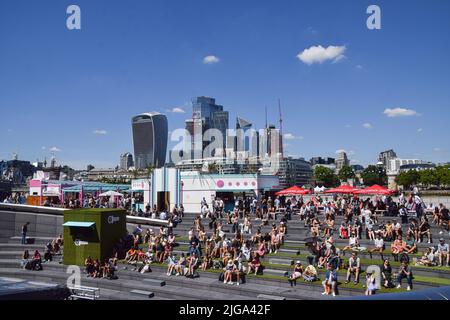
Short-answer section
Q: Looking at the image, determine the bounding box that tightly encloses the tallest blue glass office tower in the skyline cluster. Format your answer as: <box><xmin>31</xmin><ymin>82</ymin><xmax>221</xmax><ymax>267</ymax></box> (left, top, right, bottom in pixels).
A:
<box><xmin>186</xmin><ymin>97</ymin><xmax>229</xmax><ymax>158</ymax></box>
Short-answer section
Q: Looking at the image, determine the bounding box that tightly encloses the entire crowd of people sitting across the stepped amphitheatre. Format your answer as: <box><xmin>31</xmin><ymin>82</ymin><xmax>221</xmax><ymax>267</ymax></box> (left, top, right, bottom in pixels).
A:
<box><xmin>14</xmin><ymin>190</ymin><xmax>450</xmax><ymax>296</ymax></box>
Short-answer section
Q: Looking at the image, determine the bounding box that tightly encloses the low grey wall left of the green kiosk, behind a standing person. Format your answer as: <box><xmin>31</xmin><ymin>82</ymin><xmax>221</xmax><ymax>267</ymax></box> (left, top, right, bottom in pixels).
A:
<box><xmin>0</xmin><ymin>211</ymin><xmax>63</xmax><ymax>239</ymax></box>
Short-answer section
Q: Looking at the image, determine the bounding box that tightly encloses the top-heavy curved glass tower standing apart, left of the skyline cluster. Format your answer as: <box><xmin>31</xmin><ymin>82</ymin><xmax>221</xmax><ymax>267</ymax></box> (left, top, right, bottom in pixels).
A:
<box><xmin>131</xmin><ymin>112</ymin><xmax>168</xmax><ymax>169</ymax></box>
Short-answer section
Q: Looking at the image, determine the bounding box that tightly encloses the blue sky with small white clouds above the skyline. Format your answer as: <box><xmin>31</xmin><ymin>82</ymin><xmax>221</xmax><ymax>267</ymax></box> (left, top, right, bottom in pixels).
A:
<box><xmin>0</xmin><ymin>0</ymin><xmax>450</xmax><ymax>168</ymax></box>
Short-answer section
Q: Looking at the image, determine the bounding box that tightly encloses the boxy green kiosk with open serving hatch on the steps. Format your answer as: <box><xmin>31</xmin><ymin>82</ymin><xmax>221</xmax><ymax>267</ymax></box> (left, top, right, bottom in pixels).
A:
<box><xmin>63</xmin><ymin>209</ymin><xmax>127</xmax><ymax>266</ymax></box>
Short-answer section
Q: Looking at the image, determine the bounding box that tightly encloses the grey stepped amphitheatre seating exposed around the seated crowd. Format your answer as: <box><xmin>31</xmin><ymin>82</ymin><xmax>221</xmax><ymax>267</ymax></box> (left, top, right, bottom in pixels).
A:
<box><xmin>0</xmin><ymin>206</ymin><xmax>450</xmax><ymax>300</ymax></box>
